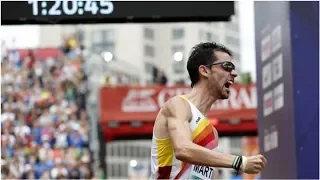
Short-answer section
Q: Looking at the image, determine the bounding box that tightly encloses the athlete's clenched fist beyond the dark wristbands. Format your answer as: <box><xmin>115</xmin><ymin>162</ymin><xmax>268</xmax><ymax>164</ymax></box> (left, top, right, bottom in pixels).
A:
<box><xmin>242</xmin><ymin>154</ymin><xmax>267</xmax><ymax>174</ymax></box>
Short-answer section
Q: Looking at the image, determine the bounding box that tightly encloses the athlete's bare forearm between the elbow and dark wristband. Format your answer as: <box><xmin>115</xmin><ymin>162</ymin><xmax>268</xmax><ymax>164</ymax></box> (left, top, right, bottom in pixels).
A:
<box><xmin>176</xmin><ymin>143</ymin><xmax>236</xmax><ymax>168</ymax></box>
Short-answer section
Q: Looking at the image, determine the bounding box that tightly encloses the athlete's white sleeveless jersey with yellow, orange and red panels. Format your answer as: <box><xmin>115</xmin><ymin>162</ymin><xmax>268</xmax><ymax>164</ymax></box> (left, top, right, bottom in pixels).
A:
<box><xmin>151</xmin><ymin>96</ymin><xmax>218</xmax><ymax>179</ymax></box>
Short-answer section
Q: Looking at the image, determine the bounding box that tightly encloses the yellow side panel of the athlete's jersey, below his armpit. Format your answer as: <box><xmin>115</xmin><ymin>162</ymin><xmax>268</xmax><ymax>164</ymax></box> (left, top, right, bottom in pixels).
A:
<box><xmin>156</xmin><ymin>138</ymin><xmax>174</xmax><ymax>167</ymax></box>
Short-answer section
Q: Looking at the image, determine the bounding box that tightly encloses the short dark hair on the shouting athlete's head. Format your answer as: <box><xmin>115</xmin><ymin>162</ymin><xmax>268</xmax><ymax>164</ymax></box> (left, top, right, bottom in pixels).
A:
<box><xmin>187</xmin><ymin>42</ymin><xmax>232</xmax><ymax>87</ymax></box>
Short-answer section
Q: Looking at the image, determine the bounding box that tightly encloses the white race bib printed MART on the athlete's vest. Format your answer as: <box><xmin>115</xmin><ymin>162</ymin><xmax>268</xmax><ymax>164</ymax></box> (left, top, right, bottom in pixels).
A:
<box><xmin>189</xmin><ymin>165</ymin><xmax>214</xmax><ymax>179</ymax></box>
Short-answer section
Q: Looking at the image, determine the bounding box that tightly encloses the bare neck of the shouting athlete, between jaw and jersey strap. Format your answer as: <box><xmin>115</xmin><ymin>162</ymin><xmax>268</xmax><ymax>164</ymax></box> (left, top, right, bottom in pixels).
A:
<box><xmin>186</xmin><ymin>84</ymin><xmax>218</xmax><ymax>116</ymax></box>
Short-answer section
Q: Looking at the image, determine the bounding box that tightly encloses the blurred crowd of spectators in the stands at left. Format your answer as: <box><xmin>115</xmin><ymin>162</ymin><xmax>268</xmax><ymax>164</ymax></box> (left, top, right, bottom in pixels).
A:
<box><xmin>1</xmin><ymin>36</ymin><xmax>93</xmax><ymax>179</ymax></box>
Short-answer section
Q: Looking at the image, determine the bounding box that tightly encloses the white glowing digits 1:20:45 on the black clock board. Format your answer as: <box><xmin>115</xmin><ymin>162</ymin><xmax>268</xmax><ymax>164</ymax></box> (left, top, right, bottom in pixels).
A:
<box><xmin>28</xmin><ymin>0</ymin><xmax>114</xmax><ymax>16</ymax></box>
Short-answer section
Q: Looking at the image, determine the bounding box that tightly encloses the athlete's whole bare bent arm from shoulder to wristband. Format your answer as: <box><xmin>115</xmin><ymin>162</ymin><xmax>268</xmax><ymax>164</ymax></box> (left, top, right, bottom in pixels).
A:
<box><xmin>163</xmin><ymin>97</ymin><xmax>235</xmax><ymax>168</ymax></box>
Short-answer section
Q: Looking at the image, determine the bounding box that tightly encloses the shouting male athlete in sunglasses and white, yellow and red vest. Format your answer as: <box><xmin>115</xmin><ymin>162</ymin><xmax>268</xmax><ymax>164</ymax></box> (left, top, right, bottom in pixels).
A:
<box><xmin>151</xmin><ymin>43</ymin><xmax>267</xmax><ymax>179</ymax></box>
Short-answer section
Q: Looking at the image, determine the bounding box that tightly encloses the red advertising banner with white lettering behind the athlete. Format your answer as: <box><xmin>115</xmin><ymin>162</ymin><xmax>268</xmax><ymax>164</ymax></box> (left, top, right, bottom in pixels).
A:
<box><xmin>100</xmin><ymin>85</ymin><xmax>257</xmax><ymax>123</ymax></box>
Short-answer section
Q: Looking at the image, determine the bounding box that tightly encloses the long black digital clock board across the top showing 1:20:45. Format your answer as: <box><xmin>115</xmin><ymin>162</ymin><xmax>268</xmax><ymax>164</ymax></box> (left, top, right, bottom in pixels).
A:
<box><xmin>1</xmin><ymin>0</ymin><xmax>234</xmax><ymax>25</ymax></box>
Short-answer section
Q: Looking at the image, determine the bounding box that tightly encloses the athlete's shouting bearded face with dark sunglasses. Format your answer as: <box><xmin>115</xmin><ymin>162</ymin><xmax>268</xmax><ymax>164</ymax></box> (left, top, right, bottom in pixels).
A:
<box><xmin>200</xmin><ymin>51</ymin><xmax>238</xmax><ymax>99</ymax></box>
